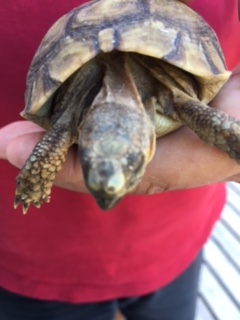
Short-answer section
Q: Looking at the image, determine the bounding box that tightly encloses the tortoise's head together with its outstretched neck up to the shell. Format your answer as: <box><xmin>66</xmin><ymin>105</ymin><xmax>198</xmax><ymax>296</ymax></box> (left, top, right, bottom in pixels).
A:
<box><xmin>78</xmin><ymin>55</ymin><xmax>155</xmax><ymax>210</ymax></box>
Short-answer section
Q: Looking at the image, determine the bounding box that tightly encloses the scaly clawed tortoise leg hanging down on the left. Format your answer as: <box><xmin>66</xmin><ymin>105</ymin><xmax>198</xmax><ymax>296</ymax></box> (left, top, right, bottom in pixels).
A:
<box><xmin>14</xmin><ymin>124</ymin><xmax>73</xmax><ymax>214</ymax></box>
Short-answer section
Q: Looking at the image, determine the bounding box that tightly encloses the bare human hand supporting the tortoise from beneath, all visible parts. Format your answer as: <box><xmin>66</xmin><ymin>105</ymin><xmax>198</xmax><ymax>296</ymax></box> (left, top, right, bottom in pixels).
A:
<box><xmin>0</xmin><ymin>66</ymin><xmax>240</xmax><ymax>194</ymax></box>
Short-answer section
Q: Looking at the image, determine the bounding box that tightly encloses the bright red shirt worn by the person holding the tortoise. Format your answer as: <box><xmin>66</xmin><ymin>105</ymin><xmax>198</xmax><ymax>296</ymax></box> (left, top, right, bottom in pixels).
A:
<box><xmin>0</xmin><ymin>0</ymin><xmax>240</xmax><ymax>302</ymax></box>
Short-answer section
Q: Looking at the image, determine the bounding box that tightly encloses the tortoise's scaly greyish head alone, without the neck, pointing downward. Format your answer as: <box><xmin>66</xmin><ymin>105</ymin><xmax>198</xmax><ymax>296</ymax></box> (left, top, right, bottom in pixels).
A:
<box><xmin>79</xmin><ymin>102</ymin><xmax>155</xmax><ymax>210</ymax></box>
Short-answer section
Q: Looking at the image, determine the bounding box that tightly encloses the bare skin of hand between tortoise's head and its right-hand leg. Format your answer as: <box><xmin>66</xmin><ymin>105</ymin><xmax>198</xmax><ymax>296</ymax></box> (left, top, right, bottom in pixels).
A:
<box><xmin>136</xmin><ymin>128</ymin><xmax>240</xmax><ymax>194</ymax></box>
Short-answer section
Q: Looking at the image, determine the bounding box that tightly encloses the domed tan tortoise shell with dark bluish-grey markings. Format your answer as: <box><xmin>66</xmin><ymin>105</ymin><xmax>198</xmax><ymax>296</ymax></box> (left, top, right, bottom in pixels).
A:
<box><xmin>22</xmin><ymin>0</ymin><xmax>230</xmax><ymax>126</ymax></box>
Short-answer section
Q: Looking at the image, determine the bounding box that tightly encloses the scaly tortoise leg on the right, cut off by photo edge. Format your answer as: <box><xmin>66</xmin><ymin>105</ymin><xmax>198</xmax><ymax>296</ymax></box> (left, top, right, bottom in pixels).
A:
<box><xmin>175</xmin><ymin>98</ymin><xmax>240</xmax><ymax>163</ymax></box>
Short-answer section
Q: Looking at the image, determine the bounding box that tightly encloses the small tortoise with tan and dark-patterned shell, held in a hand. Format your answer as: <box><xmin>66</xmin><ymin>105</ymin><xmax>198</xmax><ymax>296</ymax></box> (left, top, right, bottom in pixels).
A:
<box><xmin>14</xmin><ymin>0</ymin><xmax>240</xmax><ymax>213</ymax></box>
